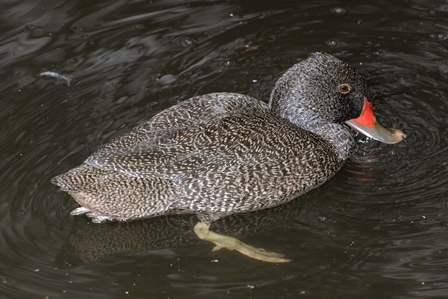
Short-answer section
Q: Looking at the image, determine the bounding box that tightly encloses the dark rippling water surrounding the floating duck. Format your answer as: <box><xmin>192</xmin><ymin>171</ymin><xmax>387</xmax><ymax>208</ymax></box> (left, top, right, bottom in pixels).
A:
<box><xmin>0</xmin><ymin>0</ymin><xmax>448</xmax><ymax>299</ymax></box>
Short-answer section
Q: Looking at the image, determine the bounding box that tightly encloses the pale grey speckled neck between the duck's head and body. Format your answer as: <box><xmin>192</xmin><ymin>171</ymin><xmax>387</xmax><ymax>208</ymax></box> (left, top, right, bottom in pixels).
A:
<box><xmin>269</xmin><ymin>98</ymin><xmax>355</xmax><ymax>161</ymax></box>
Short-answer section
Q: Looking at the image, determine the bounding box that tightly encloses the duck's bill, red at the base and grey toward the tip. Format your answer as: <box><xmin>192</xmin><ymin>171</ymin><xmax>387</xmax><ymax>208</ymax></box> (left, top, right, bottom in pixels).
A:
<box><xmin>345</xmin><ymin>99</ymin><xmax>406</xmax><ymax>144</ymax></box>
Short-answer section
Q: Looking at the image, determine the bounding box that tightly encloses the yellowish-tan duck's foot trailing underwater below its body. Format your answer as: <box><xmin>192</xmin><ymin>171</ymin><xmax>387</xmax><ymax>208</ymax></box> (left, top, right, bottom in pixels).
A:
<box><xmin>194</xmin><ymin>222</ymin><xmax>291</xmax><ymax>263</ymax></box>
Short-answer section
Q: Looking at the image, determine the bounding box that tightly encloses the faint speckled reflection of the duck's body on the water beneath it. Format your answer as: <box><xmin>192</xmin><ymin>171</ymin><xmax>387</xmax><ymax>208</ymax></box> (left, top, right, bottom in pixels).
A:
<box><xmin>56</xmin><ymin>190</ymin><xmax>328</xmax><ymax>266</ymax></box>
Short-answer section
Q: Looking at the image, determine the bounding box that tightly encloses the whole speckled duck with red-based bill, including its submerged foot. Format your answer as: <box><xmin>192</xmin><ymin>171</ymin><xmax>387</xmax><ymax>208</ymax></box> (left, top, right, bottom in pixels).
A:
<box><xmin>52</xmin><ymin>53</ymin><xmax>405</xmax><ymax>262</ymax></box>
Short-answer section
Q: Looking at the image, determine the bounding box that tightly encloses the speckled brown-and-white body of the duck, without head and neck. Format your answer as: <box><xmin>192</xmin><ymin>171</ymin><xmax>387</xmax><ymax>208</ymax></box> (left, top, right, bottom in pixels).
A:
<box><xmin>53</xmin><ymin>93</ymin><xmax>343</xmax><ymax>220</ymax></box>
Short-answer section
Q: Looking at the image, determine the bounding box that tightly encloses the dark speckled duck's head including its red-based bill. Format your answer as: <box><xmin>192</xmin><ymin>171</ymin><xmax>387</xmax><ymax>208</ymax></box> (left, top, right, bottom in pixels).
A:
<box><xmin>269</xmin><ymin>53</ymin><xmax>405</xmax><ymax>143</ymax></box>
